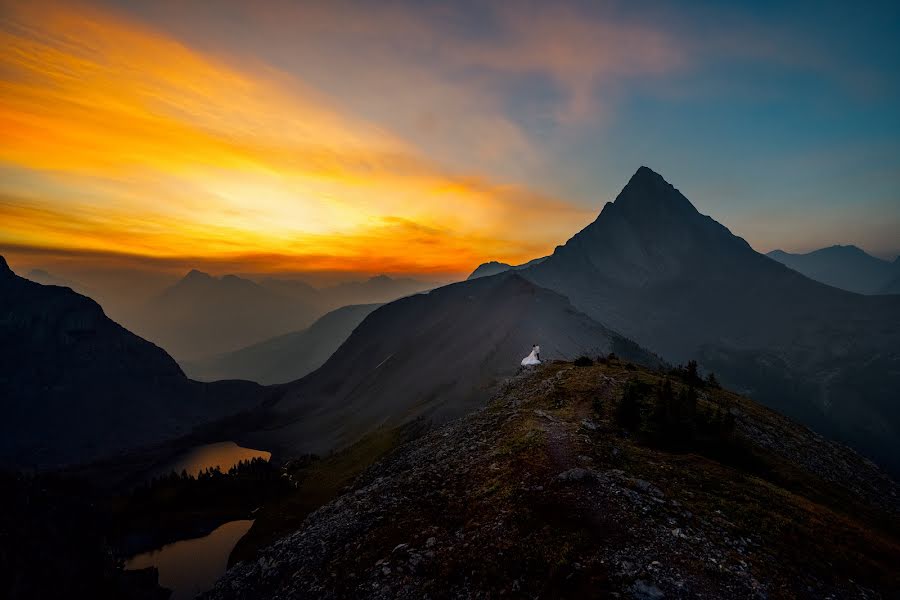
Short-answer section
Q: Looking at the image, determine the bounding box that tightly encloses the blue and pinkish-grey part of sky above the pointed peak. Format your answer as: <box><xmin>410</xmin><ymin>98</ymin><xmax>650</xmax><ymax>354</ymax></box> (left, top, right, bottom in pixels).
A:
<box><xmin>121</xmin><ymin>2</ymin><xmax>900</xmax><ymax>256</ymax></box>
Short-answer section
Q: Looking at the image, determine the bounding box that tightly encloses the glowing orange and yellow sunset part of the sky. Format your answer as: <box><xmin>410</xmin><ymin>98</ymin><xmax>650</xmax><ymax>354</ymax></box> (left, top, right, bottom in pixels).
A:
<box><xmin>0</xmin><ymin>3</ymin><xmax>594</xmax><ymax>274</ymax></box>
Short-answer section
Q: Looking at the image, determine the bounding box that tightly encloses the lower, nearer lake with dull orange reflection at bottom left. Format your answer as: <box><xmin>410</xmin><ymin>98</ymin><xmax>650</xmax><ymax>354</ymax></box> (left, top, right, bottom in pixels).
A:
<box><xmin>125</xmin><ymin>520</ymin><xmax>253</xmax><ymax>600</ymax></box>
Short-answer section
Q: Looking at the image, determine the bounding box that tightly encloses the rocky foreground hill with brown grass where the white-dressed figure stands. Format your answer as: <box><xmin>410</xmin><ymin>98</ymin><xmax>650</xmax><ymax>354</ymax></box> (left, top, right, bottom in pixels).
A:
<box><xmin>206</xmin><ymin>361</ymin><xmax>900</xmax><ymax>600</ymax></box>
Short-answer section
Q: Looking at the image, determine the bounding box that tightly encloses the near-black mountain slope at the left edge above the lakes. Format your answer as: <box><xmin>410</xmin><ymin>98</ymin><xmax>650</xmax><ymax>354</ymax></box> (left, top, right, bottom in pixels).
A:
<box><xmin>0</xmin><ymin>257</ymin><xmax>260</xmax><ymax>467</ymax></box>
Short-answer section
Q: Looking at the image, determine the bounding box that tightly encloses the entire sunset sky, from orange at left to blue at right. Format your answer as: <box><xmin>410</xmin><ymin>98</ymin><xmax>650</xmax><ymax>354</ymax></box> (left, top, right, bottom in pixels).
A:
<box><xmin>0</xmin><ymin>0</ymin><xmax>900</xmax><ymax>288</ymax></box>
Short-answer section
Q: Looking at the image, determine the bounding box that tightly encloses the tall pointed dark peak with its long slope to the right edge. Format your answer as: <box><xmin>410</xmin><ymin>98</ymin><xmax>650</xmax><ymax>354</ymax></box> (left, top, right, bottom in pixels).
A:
<box><xmin>521</xmin><ymin>167</ymin><xmax>900</xmax><ymax>468</ymax></box>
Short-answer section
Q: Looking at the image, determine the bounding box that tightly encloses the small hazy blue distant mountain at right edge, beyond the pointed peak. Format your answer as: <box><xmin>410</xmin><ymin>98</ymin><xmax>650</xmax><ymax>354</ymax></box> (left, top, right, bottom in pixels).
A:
<box><xmin>766</xmin><ymin>246</ymin><xmax>895</xmax><ymax>294</ymax></box>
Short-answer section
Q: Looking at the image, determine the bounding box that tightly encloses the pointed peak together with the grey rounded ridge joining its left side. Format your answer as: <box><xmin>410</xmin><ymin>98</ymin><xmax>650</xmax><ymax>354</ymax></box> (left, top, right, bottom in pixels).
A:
<box><xmin>232</xmin><ymin>167</ymin><xmax>900</xmax><ymax>468</ymax></box>
